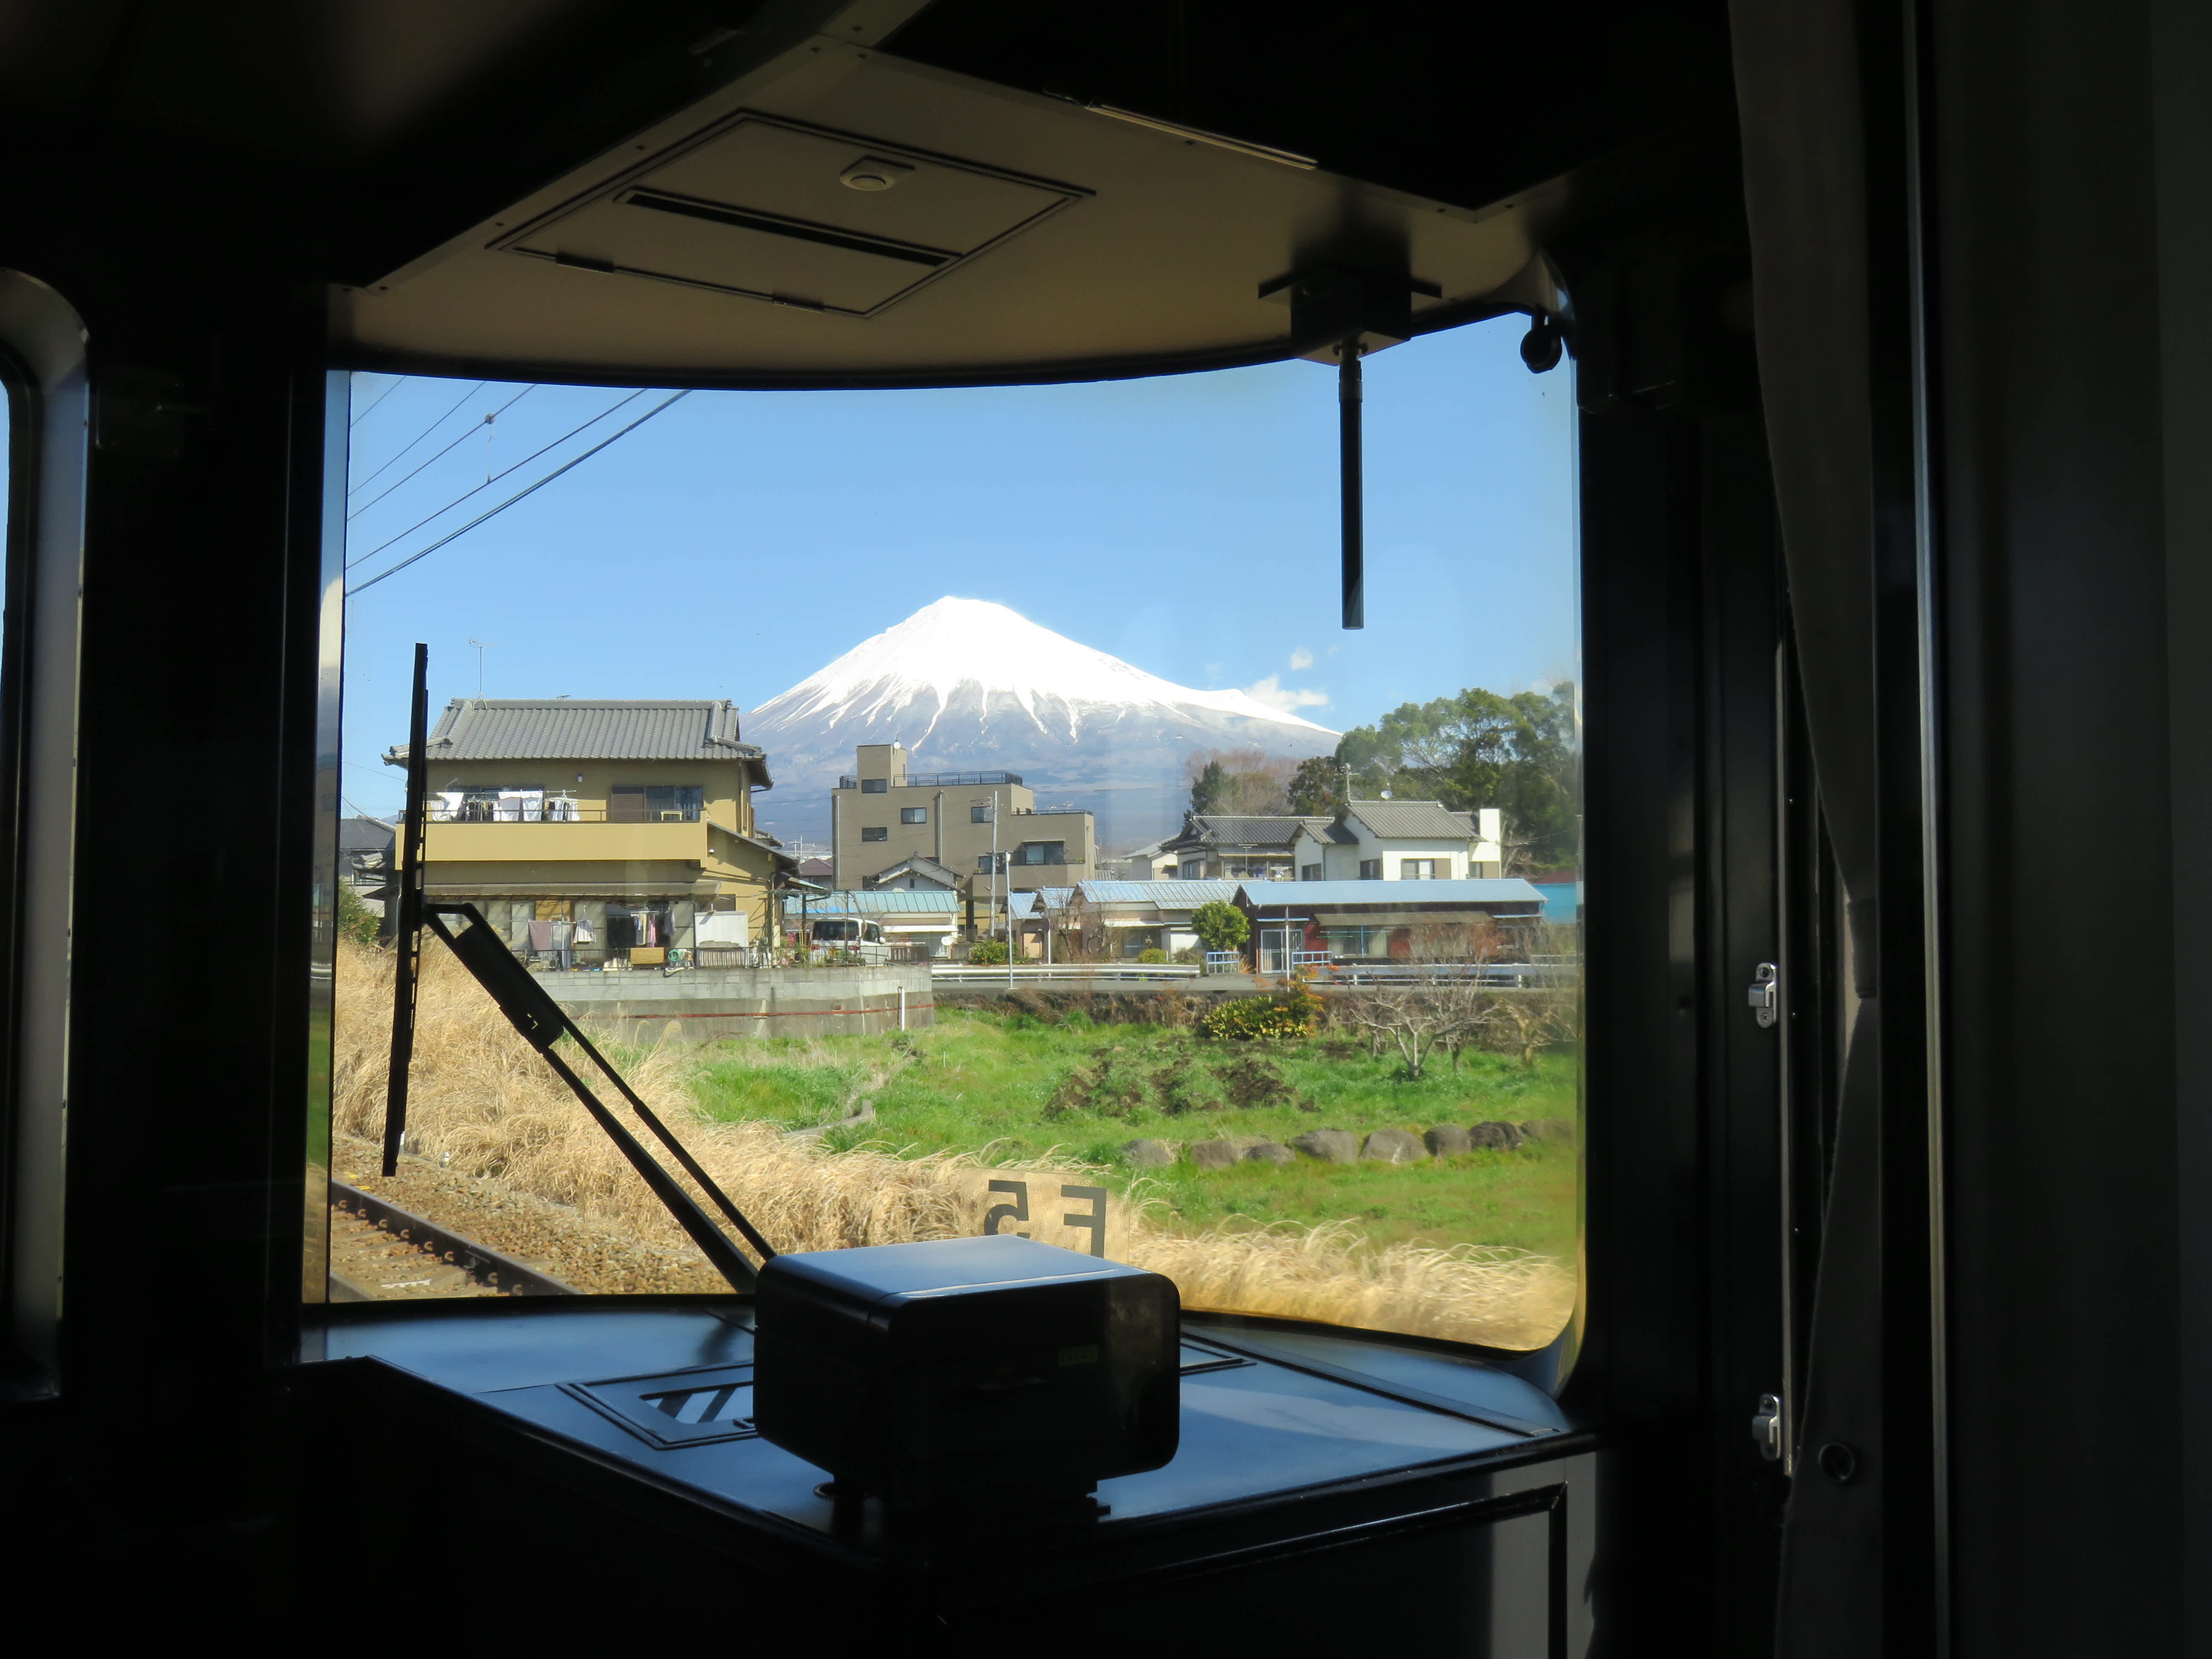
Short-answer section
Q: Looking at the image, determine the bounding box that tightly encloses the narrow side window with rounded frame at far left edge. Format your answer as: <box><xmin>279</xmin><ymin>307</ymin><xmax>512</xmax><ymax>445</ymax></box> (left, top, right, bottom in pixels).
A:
<box><xmin>0</xmin><ymin>270</ymin><xmax>88</xmax><ymax>1394</ymax></box>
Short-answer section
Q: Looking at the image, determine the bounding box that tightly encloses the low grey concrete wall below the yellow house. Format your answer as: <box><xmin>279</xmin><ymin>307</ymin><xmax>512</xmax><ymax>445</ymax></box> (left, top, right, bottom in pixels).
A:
<box><xmin>553</xmin><ymin>964</ymin><xmax>936</xmax><ymax>1042</ymax></box>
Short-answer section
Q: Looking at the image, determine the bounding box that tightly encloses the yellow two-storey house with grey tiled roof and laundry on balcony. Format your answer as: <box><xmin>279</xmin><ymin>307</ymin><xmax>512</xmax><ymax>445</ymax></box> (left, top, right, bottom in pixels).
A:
<box><xmin>385</xmin><ymin>697</ymin><xmax>796</xmax><ymax>966</ymax></box>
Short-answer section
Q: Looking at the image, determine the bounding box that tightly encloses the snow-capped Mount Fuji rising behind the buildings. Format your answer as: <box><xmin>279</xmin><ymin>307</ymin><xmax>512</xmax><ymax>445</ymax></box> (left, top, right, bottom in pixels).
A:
<box><xmin>743</xmin><ymin>600</ymin><xmax>1338</xmax><ymax>845</ymax></box>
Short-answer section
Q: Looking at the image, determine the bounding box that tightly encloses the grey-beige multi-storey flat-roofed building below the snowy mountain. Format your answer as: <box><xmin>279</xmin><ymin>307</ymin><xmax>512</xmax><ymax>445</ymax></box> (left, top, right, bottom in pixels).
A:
<box><xmin>830</xmin><ymin>743</ymin><xmax>1097</xmax><ymax>911</ymax></box>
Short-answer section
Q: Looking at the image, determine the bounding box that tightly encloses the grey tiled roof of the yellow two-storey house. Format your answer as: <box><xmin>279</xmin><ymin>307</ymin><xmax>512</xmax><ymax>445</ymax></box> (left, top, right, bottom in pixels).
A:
<box><xmin>385</xmin><ymin>697</ymin><xmax>768</xmax><ymax>783</ymax></box>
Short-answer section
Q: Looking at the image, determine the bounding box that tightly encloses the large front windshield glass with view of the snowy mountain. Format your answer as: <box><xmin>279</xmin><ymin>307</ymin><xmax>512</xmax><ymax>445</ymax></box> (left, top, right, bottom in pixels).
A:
<box><xmin>310</xmin><ymin>318</ymin><xmax>1582</xmax><ymax>1349</ymax></box>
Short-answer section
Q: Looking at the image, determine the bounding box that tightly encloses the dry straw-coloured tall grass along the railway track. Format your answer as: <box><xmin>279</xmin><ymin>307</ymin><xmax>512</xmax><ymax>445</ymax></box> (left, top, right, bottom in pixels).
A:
<box><xmin>334</xmin><ymin>940</ymin><xmax>1573</xmax><ymax>1347</ymax></box>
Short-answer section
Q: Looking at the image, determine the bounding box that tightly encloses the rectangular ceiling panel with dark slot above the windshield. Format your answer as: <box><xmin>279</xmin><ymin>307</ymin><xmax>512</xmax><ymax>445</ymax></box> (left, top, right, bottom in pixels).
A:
<box><xmin>493</xmin><ymin>111</ymin><xmax>1091</xmax><ymax>316</ymax></box>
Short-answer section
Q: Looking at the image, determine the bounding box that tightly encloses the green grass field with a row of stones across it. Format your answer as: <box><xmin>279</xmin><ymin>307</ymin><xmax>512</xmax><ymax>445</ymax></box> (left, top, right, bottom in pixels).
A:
<box><xmin>686</xmin><ymin>1009</ymin><xmax>1577</xmax><ymax>1259</ymax></box>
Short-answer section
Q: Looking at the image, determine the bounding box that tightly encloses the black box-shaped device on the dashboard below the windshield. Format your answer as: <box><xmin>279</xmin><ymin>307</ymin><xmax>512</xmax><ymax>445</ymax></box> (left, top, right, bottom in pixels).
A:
<box><xmin>752</xmin><ymin>1234</ymin><xmax>1181</xmax><ymax>1508</ymax></box>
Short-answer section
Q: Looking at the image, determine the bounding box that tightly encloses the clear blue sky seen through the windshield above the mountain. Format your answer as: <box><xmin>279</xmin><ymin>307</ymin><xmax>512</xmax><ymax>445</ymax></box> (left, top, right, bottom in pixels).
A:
<box><xmin>332</xmin><ymin>318</ymin><xmax>1577</xmax><ymax>814</ymax></box>
